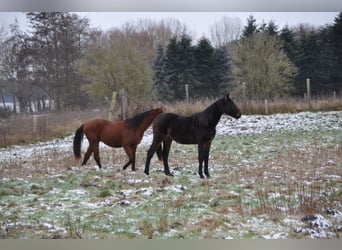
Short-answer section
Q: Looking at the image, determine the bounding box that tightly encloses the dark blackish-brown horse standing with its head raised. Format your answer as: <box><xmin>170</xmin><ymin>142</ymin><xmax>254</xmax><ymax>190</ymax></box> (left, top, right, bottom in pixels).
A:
<box><xmin>144</xmin><ymin>93</ymin><xmax>241</xmax><ymax>178</ymax></box>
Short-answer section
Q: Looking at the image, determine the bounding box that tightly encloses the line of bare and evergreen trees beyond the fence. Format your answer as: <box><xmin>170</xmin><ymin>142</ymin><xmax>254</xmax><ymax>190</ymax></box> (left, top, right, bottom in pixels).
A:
<box><xmin>0</xmin><ymin>12</ymin><xmax>342</xmax><ymax>112</ymax></box>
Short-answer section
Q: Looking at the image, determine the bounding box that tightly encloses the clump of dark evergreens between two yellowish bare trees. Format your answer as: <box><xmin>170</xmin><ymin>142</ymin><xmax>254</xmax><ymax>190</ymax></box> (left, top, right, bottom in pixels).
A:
<box><xmin>153</xmin><ymin>36</ymin><xmax>229</xmax><ymax>101</ymax></box>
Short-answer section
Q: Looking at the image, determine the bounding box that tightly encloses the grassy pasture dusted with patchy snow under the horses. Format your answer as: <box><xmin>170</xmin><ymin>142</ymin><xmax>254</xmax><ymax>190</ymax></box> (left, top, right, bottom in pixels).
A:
<box><xmin>0</xmin><ymin>111</ymin><xmax>342</xmax><ymax>239</ymax></box>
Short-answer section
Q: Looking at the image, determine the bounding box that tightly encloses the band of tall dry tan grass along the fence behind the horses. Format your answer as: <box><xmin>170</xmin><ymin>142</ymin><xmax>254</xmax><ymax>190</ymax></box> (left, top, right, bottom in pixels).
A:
<box><xmin>0</xmin><ymin>94</ymin><xmax>342</xmax><ymax>147</ymax></box>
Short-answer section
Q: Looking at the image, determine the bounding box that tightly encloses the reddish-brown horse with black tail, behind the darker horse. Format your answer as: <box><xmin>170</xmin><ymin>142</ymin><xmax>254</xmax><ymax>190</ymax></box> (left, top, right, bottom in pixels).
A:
<box><xmin>73</xmin><ymin>108</ymin><xmax>163</xmax><ymax>171</ymax></box>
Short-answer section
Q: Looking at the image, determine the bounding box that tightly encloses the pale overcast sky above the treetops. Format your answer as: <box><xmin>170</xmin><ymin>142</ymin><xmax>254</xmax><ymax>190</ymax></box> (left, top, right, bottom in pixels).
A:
<box><xmin>0</xmin><ymin>12</ymin><xmax>338</xmax><ymax>37</ymax></box>
